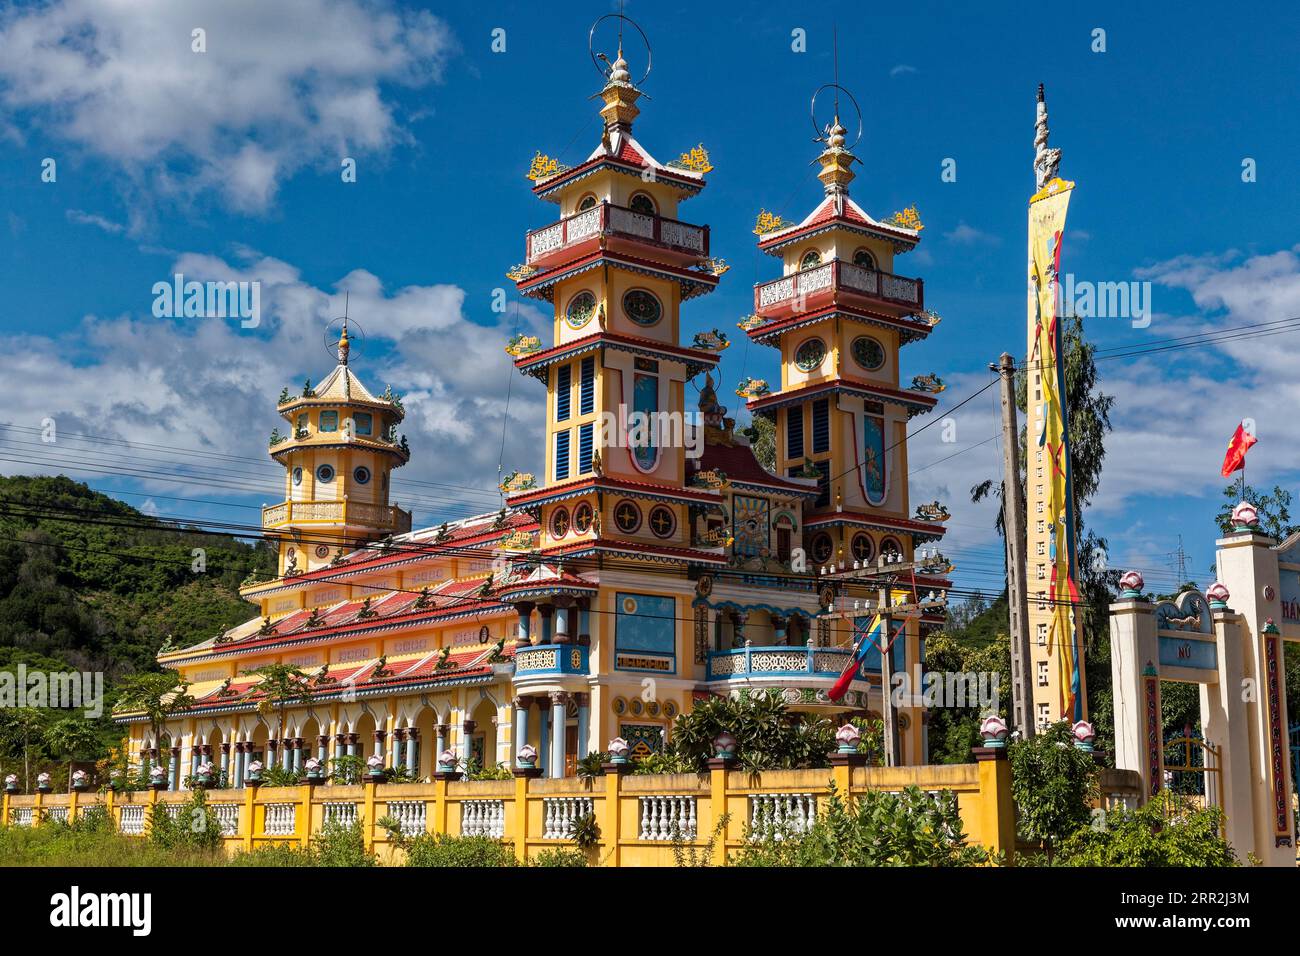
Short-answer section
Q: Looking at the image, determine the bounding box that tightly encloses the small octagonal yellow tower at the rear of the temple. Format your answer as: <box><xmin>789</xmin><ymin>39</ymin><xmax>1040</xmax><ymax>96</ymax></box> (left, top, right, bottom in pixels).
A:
<box><xmin>261</xmin><ymin>321</ymin><xmax>411</xmax><ymax>576</ymax></box>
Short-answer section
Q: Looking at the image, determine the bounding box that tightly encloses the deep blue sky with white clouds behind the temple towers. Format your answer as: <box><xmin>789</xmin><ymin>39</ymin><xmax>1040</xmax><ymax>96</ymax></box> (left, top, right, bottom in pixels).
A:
<box><xmin>0</xmin><ymin>0</ymin><xmax>1300</xmax><ymax>591</ymax></box>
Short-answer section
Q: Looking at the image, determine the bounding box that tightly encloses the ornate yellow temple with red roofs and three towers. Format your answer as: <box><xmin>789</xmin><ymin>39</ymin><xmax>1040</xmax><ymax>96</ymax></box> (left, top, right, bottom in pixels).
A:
<box><xmin>120</xmin><ymin>39</ymin><xmax>946</xmax><ymax>787</ymax></box>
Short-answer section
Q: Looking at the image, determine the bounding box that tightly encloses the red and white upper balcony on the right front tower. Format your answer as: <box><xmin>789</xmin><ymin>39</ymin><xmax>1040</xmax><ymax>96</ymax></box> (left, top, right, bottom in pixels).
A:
<box><xmin>754</xmin><ymin>259</ymin><xmax>924</xmax><ymax>319</ymax></box>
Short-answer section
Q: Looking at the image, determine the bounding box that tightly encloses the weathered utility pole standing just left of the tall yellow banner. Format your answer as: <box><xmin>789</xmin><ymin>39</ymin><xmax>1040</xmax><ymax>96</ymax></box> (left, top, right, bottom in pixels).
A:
<box><xmin>989</xmin><ymin>352</ymin><xmax>1034</xmax><ymax>740</ymax></box>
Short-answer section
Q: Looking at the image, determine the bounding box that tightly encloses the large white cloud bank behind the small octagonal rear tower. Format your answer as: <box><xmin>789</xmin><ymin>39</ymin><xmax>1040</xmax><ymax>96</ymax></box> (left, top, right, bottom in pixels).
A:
<box><xmin>0</xmin><ymin>250</ymin><xmax>549</xmax><ymax>522</ymax></box>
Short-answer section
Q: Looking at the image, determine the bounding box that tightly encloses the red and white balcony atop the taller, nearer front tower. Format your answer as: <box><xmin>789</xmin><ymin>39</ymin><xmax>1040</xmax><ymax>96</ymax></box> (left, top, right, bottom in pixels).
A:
<box><xmin>527</xmin><ymin>203</ymin><xmax>709</xmax><ymax>269</ymax></box>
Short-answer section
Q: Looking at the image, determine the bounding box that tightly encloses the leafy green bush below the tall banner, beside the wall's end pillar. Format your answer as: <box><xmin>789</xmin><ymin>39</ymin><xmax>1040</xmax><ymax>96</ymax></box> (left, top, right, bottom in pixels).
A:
<box><xmin>1008</xmin><ymin>721</ymin><xmax>1100</xmax><ymax>861</ymax></box>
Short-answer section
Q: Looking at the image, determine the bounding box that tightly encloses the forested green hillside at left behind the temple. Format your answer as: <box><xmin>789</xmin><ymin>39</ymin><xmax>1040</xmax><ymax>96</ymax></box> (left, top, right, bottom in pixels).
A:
<box><xmin>0</xmin><ymin>476</ymin><xmax>274</xmax><ymax>780</ymax></box>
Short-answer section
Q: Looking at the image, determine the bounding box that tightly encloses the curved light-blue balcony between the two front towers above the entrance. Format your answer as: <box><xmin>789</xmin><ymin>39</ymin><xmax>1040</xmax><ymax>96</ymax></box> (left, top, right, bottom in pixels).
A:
<box><xmin>705</xmin><ymin>643</ymin><xmax>868</xmax><ymax>710</ymax></box>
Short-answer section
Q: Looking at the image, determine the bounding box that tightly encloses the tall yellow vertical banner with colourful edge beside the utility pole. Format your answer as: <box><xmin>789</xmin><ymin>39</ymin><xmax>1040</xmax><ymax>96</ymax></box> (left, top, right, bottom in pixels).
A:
<box><xmin>1028</xmin><ymin>178</ymin><xmax>1087</xmax><ymax>721</ymax></box>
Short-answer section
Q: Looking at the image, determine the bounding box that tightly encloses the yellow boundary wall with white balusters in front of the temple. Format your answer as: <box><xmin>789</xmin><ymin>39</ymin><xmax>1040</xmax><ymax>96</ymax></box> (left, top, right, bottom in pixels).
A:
<box><xmin>0</xmin><ymin>754</ymin><xmax>1141</xmax><ymax>866</ymax></box>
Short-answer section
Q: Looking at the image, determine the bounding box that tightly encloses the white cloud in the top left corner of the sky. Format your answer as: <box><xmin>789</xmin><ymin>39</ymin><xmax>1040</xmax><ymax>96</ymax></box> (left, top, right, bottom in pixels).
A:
<box><xmin>0</xmin><ymin>0</ymin><xmax>454</xmax><ymax>212</ymax></box>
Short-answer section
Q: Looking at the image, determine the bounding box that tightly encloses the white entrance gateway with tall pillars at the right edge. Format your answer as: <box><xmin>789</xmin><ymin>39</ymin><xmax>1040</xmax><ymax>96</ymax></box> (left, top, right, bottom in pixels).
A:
<box><xmin>1110</xmin><ymin>503</ymin><xmax>1300</xmax><ymax>866</ymax></box>
